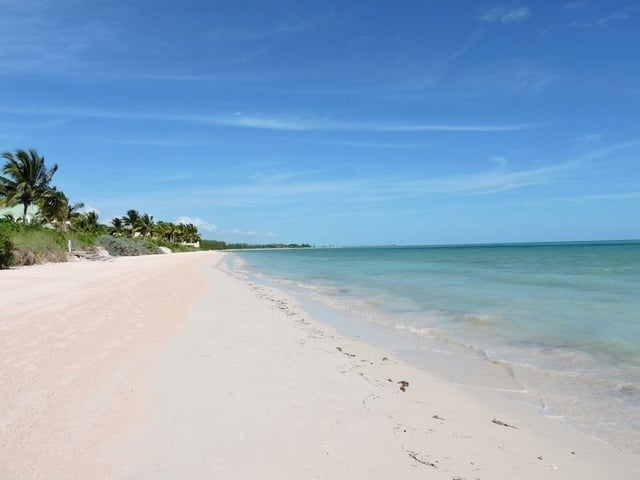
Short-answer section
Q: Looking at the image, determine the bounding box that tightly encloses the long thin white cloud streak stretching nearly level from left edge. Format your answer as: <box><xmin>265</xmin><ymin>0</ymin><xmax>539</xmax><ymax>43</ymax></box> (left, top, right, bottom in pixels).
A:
<box><xmin>0</xmin><ymin>105</ymin><xmax>536</xmax><ymax>133</ymax></box>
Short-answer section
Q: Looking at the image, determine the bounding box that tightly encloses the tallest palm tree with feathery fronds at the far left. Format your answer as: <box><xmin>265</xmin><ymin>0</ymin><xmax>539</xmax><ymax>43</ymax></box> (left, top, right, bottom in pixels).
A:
<box><xmin>0</xmin><ymin>149</ymin><xmax>58</xmax><ymax>223</ymax></box>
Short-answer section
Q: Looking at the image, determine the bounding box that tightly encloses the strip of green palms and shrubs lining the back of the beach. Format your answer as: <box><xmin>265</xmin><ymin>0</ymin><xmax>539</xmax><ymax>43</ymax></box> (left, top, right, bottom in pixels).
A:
<box><xmin>0</xmin><ymin>149</ymin><xmax>311</xmax><ymax>268</ymax></box>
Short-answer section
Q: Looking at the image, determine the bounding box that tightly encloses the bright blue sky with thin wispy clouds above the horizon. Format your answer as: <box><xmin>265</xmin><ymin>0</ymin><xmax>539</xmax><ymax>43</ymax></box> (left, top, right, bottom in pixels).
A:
<box><xmin>0</xmin><ymin>0</ymin><xmax>640</xmax><ymax>245</ymax></box>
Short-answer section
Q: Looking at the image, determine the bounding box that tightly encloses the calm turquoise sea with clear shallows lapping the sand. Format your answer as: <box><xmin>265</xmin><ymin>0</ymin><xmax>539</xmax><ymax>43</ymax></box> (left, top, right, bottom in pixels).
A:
<box><xmin>228</xmin><ymin>242</ymin><xmax>640</xmax><ymax>450</ymax></box>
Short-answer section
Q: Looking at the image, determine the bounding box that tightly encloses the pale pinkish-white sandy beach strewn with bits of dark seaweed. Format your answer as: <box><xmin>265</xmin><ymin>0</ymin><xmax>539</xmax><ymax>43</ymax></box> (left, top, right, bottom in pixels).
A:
<box><xmin>0</xmin><ymin>253</ymin><xmax>640</xmax><ymax>479</ymax></box>
